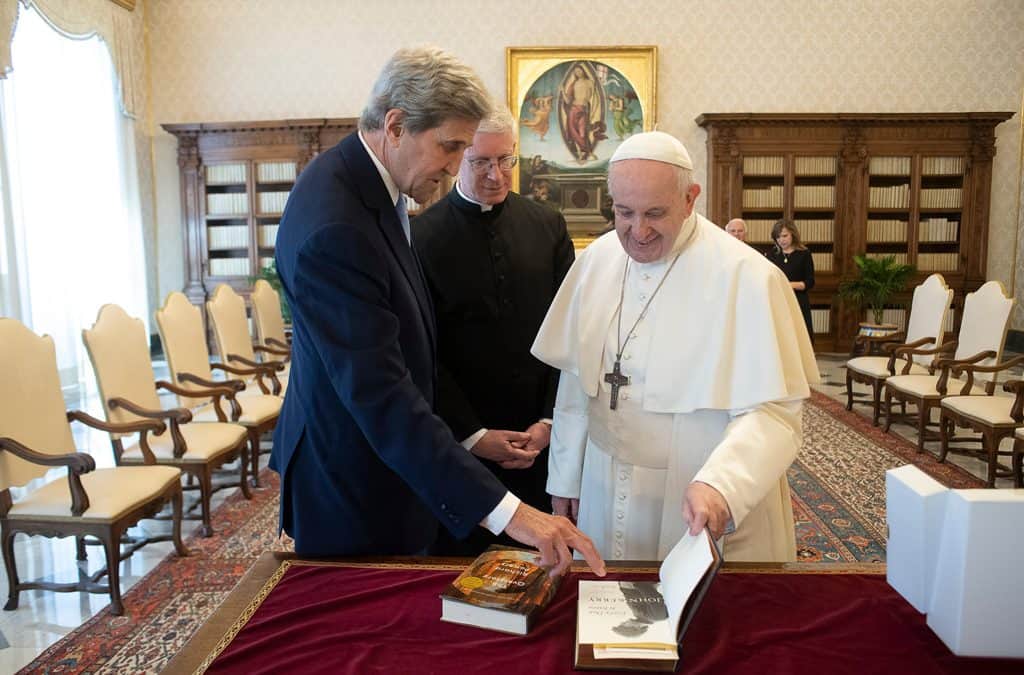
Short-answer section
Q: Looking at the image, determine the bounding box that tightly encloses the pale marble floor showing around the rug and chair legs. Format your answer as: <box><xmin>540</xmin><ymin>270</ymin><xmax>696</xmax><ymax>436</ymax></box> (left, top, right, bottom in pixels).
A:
<box><xmin>0</xmin><ymin>354</ymin><xmax>1020</xmax><ymax>673</ymax></box>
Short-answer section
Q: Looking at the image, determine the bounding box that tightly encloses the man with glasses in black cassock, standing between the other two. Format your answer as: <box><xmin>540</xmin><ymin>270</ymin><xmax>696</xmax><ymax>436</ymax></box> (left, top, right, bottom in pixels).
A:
<box><xmin>412</xmin><ymin>110</ymin><xmax>574</xmax><ymax>555</ymax></box>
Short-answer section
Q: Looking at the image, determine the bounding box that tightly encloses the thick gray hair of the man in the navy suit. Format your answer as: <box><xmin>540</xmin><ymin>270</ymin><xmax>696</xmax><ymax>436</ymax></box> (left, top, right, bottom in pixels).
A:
<box><xmin>359</xmin><ymin>46</ymin><xmax>492</xmax><ymax>133</ymax></box>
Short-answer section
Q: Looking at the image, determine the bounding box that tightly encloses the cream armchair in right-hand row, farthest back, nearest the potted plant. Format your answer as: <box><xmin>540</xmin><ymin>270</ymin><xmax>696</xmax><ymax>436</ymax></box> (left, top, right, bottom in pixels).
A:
<box><xmin>846</xmin><ymin>273</ymin><xmax>953</xmax><ymax>426</ymax></box>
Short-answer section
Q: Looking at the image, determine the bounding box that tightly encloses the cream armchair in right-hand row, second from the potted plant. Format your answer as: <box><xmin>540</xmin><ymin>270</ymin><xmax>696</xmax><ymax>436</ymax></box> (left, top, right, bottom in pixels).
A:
<box><xmin>883</xmin><ymin>282</ymin><xmax>1014</xmax><ymax>452</ymax></box>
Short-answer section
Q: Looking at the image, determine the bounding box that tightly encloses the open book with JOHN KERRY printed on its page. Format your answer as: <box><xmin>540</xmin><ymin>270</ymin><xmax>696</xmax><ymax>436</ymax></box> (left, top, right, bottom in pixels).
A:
<box><xmin>574</xmin><ymin>529</ymin><xmax>722</xmax><ymax>672</ymax></box>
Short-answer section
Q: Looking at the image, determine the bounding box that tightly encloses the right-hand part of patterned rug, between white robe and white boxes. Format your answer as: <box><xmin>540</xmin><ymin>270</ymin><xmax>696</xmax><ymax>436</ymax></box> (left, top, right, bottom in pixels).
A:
<box><xmin>787</xmin><ymin>391</ymin><xmax>984</xmax><ymax>562</ymax></box>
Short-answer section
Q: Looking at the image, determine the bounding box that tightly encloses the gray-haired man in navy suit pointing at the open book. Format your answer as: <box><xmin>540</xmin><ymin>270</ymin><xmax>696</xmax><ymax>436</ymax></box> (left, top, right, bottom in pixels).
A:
<box><xmin>270</xmin><ymin>47</ymin><xmax>604</xmax><ymax>574</ymax></box>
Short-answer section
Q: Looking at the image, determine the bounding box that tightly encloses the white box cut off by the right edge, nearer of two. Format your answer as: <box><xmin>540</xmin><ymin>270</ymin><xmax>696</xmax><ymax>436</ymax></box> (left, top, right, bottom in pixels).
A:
<box><xmin>928</xmin><ymin>490</ymin><xmax>1024</xmax><ymax>659</ymax></box>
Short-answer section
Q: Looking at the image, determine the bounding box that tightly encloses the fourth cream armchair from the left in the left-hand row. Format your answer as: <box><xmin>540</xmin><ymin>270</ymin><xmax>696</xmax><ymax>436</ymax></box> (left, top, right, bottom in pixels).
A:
<box><xmin>206</xmin><ymin>284</ymin><xmax>288</xmax><ymax>396</ymax></box>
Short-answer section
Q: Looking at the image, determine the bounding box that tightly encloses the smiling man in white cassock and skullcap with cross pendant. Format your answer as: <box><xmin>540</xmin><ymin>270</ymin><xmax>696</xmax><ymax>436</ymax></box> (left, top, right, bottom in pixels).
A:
<box><xmin>532</xmin><ymin>131</ymin><xmax>818</xmax><ymax>561</ymax></box>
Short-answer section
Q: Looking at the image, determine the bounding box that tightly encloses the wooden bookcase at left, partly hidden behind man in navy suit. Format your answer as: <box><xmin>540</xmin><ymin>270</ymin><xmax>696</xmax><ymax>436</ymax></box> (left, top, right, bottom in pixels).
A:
<box><xmin>162</xmin><ymin>118</ymin><xmax>356</xmax><ymax>307</ymax></box>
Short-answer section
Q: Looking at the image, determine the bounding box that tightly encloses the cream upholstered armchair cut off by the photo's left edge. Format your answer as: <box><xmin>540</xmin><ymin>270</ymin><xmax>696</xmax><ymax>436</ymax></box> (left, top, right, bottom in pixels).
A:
<box><xmin>0</xmin><ymin>319</ymin><xmax>188</xmax><ymax>615</ymax></box>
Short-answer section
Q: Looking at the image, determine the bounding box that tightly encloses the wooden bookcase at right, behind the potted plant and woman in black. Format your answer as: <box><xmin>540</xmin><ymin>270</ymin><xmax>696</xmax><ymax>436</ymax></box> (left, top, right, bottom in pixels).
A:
<box><xmin>696</xmin><ymin>113</ymin><xmax>1013</xmax><ymax>351</ymax></box>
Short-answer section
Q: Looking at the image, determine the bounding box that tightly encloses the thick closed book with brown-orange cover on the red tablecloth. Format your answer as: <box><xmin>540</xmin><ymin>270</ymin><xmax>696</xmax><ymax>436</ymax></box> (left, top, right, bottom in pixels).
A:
<box><xmin>440</xmin><ymin>544</ymin><xmax>561</xmax><ymax>635</ymax></box>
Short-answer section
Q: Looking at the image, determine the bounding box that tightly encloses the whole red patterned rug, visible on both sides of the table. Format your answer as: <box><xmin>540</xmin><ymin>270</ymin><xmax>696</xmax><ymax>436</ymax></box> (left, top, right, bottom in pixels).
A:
<box><xmin>22</xmin><ymin>392</ymin><xmax>982</xmax><ymax>674</ymax></box>
